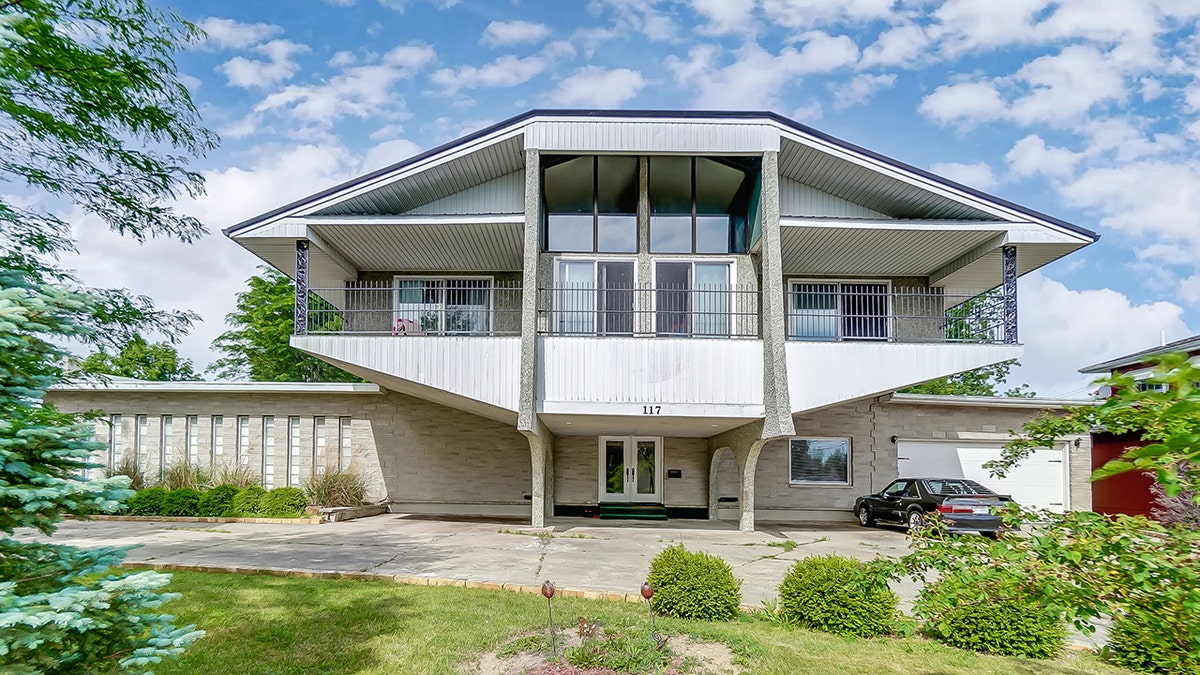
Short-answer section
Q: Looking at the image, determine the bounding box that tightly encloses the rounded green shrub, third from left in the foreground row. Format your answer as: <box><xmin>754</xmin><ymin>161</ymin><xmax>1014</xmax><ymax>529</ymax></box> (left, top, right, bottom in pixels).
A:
<box><xmin>922</xmin><ymin>575</ymin><xmax>1067</xmax><ymax>658</ymax></box>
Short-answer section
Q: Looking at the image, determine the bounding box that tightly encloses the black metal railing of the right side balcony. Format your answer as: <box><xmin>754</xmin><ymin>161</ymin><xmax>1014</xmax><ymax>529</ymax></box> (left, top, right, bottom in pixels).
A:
<box><xmin>785</xmin><ymin>281</ymin><xmax>1004</xmax><ymax>344</ymax></box>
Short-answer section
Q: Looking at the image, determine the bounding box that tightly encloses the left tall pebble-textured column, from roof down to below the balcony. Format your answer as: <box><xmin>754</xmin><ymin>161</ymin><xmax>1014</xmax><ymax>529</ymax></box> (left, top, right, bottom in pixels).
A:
<box><xmin>517</xmin><ymin>149</ymin><xmax>541</xmax><ymax>435</ymax></box>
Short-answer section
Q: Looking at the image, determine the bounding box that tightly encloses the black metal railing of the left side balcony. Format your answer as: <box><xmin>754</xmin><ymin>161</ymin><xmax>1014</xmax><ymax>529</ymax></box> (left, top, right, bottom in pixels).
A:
<box><xmin>296</xmin><ymin>277</ymin><xmax>521</xmax><ymax>336</ymax></box>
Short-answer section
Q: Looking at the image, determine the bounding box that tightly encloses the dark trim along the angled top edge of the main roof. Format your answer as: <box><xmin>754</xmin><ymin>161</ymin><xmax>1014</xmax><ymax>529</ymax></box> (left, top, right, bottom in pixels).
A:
<box><xmin>222</xmin><ymin>109</ymin><xmax>1100</xmax><ymax>241</ymax></box>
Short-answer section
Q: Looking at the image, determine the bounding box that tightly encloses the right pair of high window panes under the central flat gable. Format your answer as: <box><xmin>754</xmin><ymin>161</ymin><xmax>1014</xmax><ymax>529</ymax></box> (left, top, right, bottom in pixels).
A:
<box><xmin>649</xmin><ymin>156</ymin><xmax>752</xmax><ymax>253</ymax></box>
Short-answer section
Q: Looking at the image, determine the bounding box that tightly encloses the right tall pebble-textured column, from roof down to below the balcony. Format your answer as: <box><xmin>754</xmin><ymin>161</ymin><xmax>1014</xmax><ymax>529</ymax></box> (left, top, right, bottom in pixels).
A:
<box><xmin>750</xmin><ymin>150</ymin><xmax>796</xmax><ymax>439</ymax></box>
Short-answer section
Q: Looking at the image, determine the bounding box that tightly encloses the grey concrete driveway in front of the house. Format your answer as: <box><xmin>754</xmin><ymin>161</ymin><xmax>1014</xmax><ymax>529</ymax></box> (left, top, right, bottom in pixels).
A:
<box><xmin>26</xmin><ymin>514</ymin><xmax>917</xmax><ymax>605</ymax></box>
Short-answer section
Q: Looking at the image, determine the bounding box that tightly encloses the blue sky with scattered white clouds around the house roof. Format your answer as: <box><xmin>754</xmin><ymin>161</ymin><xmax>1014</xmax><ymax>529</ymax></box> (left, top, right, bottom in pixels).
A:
<box><xmin>62</xmin><ymin>0</ymin><xmax>1200</xmax><ymax>396</ymax></box>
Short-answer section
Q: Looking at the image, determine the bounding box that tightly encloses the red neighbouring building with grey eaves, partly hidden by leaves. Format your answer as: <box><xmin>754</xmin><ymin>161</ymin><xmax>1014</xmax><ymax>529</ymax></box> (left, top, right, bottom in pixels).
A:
<box><xmin>1080</xmin><ymin>335</ymin><xmax>1200</xmax><ymax>518</ymax></box>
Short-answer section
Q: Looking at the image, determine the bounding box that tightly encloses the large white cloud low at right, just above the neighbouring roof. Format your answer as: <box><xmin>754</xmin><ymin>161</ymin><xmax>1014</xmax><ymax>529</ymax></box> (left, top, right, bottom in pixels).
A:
<box><xmin>1009</xmin><ymin>271</ymin><xmax>1193</xmax><ymax>396</ymax></box>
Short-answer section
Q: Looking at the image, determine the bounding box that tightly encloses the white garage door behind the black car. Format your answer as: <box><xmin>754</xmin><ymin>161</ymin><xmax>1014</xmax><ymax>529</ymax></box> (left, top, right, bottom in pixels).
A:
<box><xmin>896</xmin><ymin>441</ymin><xmax>1070</xmax><ymax>513</ymax></box>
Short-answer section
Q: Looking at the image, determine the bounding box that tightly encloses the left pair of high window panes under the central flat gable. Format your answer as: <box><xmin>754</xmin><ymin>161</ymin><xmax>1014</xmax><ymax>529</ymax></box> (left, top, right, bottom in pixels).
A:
<box><xmin>542</xmin><ymin>155</ymin><xmax>637</xmax><ymax>253</ymax></box>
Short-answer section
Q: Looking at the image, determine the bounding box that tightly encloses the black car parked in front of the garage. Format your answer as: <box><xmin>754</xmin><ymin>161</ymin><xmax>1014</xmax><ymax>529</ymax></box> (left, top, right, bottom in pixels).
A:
<box><xmin>854</xmin><ymin>478</ymin><xmax>1013</xmax><ymax>537</ymax></box>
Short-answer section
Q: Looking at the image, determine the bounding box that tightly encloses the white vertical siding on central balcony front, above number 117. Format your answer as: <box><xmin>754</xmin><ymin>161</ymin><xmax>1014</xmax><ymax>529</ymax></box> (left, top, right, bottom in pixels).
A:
<box><xmin>538</xmin><ymin>338</ymin><xmax>762</xmax><ymax>406</ymax></box>
